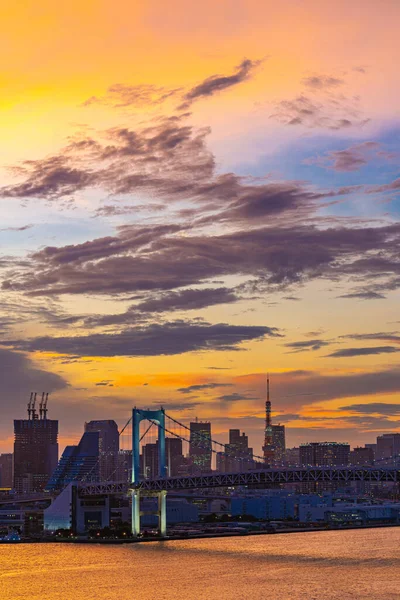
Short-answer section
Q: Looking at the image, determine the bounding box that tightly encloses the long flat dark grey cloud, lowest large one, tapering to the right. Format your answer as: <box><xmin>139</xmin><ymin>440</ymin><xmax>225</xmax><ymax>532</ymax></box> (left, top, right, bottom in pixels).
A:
<box><xmin>3</xmin><ymin>321</ymin><xmax>280</xmax><ymax>356</ymax></box>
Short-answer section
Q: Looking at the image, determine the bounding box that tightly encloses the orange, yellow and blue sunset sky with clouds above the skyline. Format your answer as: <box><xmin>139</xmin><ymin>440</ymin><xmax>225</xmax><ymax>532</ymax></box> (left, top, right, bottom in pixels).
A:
<box><xmin>0</xmin><ymin>0</ymin><xmax>400</xmax><ymax>454</ymax></box>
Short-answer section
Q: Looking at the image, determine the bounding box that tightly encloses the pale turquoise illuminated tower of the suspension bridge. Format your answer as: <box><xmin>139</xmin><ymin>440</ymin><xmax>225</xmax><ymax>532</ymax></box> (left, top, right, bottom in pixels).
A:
<box><xmin>131</xmin><ymin>408</ymin><xmax>167</xmax><ymax>537</ymax></box>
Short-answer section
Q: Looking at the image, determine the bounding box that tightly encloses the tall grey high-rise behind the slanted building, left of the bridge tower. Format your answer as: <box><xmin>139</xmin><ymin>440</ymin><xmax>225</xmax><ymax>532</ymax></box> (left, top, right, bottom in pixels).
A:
<box><xmin>85</xmin><ymin>419</ymin><xmax>119</xmax><ymax>481</ymax></box>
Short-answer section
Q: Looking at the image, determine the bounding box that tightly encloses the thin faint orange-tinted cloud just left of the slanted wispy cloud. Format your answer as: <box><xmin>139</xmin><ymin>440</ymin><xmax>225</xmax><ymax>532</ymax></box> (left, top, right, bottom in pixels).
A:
<box><xmin>82</xmin><ymin>83</ymin><xmax>182</xmax><ymax>108</ymax></box>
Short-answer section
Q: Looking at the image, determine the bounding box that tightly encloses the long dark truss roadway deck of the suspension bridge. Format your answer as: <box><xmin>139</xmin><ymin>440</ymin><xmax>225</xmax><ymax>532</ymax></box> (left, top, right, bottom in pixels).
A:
<box><xmin>78</xmin><ymin>467</ymin><xmax>400</xmax><ymax>495</ymax></box>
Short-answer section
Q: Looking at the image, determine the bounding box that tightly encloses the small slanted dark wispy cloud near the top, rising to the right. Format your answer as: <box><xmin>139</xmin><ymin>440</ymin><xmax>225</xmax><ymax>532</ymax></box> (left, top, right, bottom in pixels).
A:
<box><xmin>179</xmin><ymin>58</ymin><xmax>262</xmax><ymax>109</ymax></box>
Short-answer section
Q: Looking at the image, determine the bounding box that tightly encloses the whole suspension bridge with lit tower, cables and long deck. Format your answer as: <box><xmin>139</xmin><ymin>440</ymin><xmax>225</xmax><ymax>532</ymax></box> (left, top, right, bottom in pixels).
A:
<box><xmin>72</xmin><ymin>408</ymin><xmax>400</xmax><ymax>536</ymax></box>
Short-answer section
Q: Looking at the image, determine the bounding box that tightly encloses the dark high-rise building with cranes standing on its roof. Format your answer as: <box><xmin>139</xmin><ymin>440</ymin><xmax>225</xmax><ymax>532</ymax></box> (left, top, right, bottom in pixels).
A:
<box><xmin>14</xmin><ymin>394</ymin><xmax>58</xmax><ymax>494</ymax></box>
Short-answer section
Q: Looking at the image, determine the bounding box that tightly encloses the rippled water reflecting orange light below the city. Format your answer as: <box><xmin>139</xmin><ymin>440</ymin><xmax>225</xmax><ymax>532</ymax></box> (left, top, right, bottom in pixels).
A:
<box><xmin>0</xmin><ymin>528</ymin><xmax>400</xmax><ymax>600</ymax></box>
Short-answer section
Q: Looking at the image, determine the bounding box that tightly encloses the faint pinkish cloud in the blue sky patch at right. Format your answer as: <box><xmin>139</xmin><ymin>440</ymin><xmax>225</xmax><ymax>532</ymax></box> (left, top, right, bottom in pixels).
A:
<box><xmin>303</xmin><ymin>142</ymin><xmax>381</xmax><ymax>172</ymax></box>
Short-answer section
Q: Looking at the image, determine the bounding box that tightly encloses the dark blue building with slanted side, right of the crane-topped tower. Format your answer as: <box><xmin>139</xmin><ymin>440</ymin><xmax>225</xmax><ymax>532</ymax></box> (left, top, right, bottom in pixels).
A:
<box><xmin>46</xmin><ymin>431</ymin><xmax>100</xmax><ymax>491</ymax></box>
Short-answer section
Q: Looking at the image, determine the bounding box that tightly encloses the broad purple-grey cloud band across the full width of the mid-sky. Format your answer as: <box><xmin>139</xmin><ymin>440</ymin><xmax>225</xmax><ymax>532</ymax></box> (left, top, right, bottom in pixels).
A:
<box><xmin>3</xmin><ymin>219</ymin><xmax>400</xmax><ymax>296</ymax></box>
